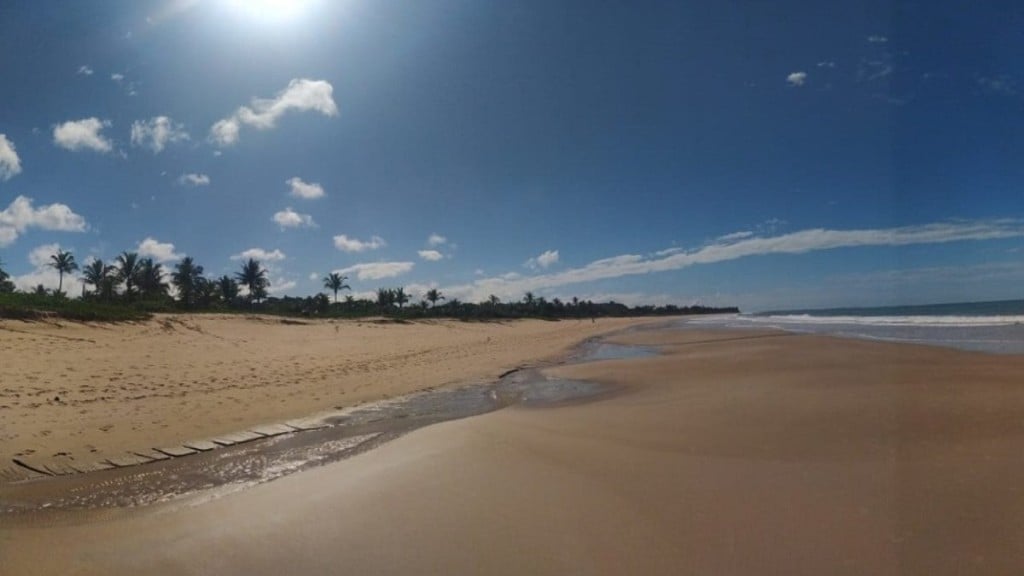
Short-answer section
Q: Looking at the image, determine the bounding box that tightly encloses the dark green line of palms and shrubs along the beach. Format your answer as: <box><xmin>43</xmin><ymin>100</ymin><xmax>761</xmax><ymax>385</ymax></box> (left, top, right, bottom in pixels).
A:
<box><xmin>0</xmin><ymin>245</ymin><xmax>738</xmax><ymax>322</ymax></box>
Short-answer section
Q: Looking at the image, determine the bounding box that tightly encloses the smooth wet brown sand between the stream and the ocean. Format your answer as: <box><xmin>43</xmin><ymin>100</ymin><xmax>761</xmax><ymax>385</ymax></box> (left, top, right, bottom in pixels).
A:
<box><xmin>0</xmin><ymin>331</ymin><xmax>1024</xmax><ymax>575</ymax></box>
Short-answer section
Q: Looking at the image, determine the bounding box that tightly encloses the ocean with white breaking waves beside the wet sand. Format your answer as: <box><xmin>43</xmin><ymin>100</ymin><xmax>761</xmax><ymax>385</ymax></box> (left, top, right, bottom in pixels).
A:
<box><xmin>688</xmin><ymin>300</ymin><xmax>1024</xmax><ymax>354</ymax></box>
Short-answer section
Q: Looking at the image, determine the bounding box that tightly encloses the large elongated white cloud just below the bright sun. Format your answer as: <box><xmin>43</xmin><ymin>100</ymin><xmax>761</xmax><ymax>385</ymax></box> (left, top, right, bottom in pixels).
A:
<box><xmin>210</xmin><ymin>78</ymin><xmax>338</xmax><ymax>147</ymax></box>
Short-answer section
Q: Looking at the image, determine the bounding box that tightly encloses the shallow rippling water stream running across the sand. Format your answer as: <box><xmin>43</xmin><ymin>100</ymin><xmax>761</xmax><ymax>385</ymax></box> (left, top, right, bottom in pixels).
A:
<box><xmin>0</xmin><ymin>334</ymin><xmax>656</xmax><ymax>523</ymax></box>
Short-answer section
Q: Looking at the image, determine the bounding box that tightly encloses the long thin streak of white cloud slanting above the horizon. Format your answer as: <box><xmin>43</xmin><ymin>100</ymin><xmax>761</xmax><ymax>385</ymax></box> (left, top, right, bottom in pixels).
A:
<box><xmin>444</xmin><ymin>219</ymin><xmax>1024</xmax><ymax>301</ymax></box>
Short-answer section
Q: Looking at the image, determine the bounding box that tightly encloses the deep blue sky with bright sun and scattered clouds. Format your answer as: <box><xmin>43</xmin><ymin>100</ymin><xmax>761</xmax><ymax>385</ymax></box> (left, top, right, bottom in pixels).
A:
<box><xmin>0</xmin><ymin>0</ymin><xmax>1024</xmax><ymax>310</ymax></box>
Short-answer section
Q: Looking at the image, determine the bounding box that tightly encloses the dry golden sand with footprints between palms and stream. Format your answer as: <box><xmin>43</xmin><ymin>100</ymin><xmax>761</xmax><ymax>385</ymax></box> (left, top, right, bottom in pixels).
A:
<box><xmin>0</xmin><ymin>315</ymin><xmax>649</xmax><ymax>482</ymax></box>
